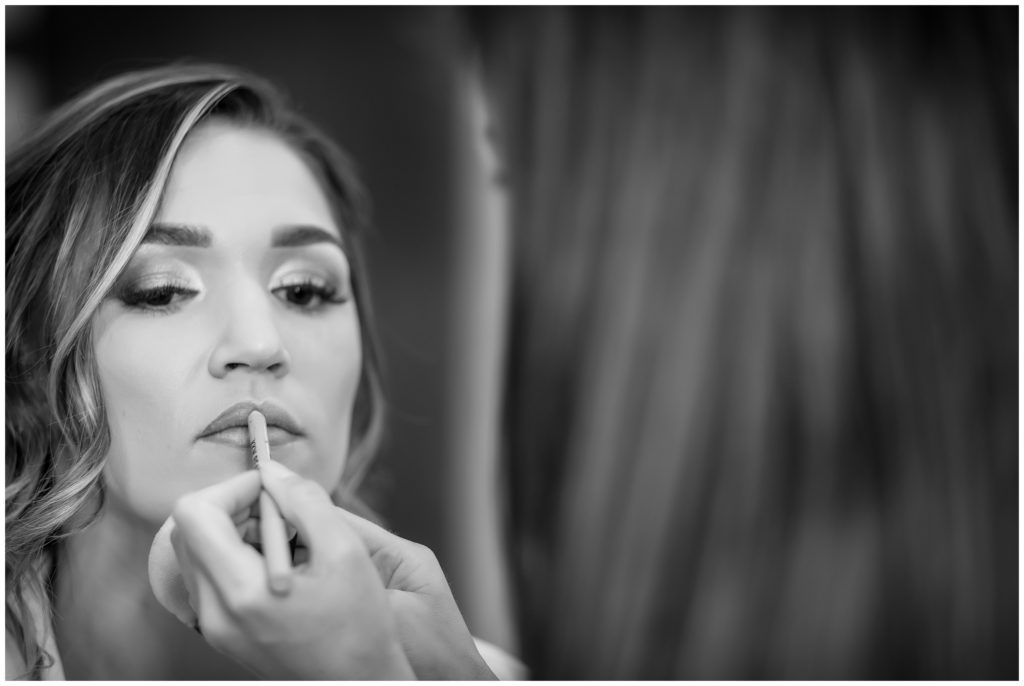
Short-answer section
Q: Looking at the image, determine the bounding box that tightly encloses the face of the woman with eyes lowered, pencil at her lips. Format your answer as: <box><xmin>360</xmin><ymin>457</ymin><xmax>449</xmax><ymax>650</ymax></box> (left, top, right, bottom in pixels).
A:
<box><xmin>92</xmin><ymin>120</ymin><xmax>362</xmax><ymax>522</ymax></box>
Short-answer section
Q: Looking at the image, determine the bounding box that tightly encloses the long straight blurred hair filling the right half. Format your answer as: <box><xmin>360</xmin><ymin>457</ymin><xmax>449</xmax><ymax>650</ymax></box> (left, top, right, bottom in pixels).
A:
<box><xmin>474</xmin><ymin>7</ymin><xmax>1018</xmax><ymax>679</ymax></box>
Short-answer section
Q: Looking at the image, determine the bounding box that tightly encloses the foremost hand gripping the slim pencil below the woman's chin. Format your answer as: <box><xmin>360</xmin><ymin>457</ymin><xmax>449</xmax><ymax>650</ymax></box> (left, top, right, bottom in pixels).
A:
<box><xmin>171</xmin><ymin>468</ymin><xmax>414</xmax><ymax>680</ymax></box>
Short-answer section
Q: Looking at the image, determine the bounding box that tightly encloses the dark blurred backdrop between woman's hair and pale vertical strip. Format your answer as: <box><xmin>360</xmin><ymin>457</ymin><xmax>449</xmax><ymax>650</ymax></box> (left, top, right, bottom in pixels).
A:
<box><xmin>5</xmin><ymin>1</ymin><xmax>468</xmax><ymax>622</ymax></box>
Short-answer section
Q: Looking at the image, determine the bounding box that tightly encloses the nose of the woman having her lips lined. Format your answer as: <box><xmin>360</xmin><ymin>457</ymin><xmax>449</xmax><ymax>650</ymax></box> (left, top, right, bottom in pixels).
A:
<box><xmin>210</xmin><ymin>289</ymin><xmax>290</xmax><ymax>379</ymax></box>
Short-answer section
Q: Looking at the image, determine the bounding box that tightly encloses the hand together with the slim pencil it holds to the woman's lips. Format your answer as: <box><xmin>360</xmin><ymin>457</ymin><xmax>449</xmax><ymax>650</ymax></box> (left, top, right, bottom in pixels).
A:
<box><xmin>151</xmin><ymin>444</ymin><xmax>415</xmax><ymax>680</ymax></box>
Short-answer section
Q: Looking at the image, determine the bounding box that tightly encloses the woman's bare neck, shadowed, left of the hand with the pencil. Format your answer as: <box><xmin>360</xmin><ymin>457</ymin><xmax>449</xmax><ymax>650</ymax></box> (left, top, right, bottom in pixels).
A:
<box><xmin>54</xmin><ymin>503</ymin><xmax>253</xmax><ymax>680</ymax></box>
